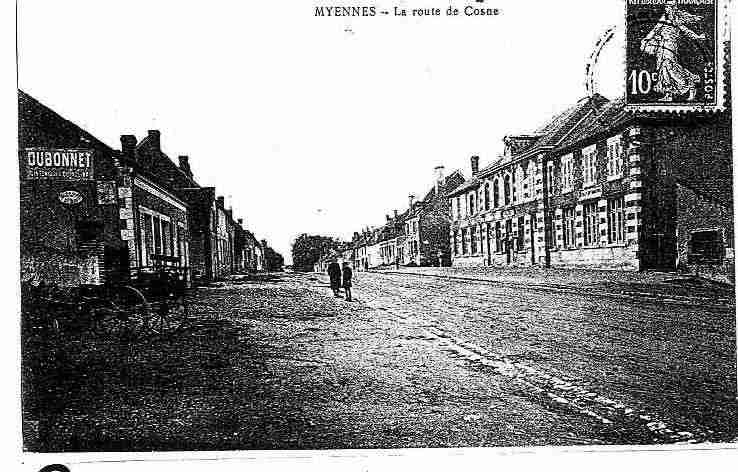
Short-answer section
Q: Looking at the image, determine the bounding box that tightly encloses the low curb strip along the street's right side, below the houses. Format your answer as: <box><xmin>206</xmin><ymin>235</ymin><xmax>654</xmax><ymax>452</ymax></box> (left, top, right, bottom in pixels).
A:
<box><xmin>367</xmin><ymin>270</ymin><xmax>735</xmax><ymax>309</ymax></box>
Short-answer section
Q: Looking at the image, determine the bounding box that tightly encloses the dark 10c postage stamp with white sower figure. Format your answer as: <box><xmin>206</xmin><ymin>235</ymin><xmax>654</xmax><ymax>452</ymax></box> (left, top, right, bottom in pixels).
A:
<box><xmin>625</xmin><ymin>0</ymin><xmax>727</xmax><ymax>112</ymax></box>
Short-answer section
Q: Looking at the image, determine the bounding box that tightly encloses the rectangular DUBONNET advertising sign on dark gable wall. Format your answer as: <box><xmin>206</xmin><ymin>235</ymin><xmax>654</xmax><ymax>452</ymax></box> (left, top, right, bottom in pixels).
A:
<box><xmin>21</xmin><ymin>148</ymin><xmax>95</xmax><ymax>180</ymax></box>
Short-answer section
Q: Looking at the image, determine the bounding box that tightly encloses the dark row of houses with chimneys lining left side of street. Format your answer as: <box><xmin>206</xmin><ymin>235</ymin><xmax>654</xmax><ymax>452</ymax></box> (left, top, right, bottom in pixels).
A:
<box><xmin>18</xmin><ymin>91</ymin><xmax>264</xmax><ymax>286</ymax></box>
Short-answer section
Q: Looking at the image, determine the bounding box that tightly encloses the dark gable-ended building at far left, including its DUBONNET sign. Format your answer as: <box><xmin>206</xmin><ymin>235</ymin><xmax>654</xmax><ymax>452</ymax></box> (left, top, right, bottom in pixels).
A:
<box><xmin>18</xmin><ymin>90</ymin><xmax>128</xmax><ymax>286</ymax></box>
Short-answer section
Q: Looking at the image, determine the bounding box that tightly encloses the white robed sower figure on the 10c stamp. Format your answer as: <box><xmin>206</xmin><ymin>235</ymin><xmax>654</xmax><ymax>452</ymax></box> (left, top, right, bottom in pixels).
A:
<box><xmin>641</xmin><ymin>0</ymin><xmax>705</xmax><ymax>102</ymax></box>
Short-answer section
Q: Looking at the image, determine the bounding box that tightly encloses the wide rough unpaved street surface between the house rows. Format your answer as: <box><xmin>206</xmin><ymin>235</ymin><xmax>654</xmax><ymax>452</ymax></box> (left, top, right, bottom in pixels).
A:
<box><xmin>24</xmin><ymin>273</ymin><xmax>738</xmax><ymax>450</ymax></box>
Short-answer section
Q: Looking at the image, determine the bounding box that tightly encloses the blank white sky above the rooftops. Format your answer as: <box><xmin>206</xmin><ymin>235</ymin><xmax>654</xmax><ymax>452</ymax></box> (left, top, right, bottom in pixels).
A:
<box><xmin>18</xmin><ymin>0</ymin><xmax>624</xmax><ymax>262</ymax></box>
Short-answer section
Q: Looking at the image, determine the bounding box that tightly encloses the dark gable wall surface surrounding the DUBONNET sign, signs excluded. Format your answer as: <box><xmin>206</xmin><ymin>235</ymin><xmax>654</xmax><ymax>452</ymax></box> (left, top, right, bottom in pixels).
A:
<box><xmin>18</xmin><ymin>92</ymin><xmax>126</xmax><ymax>285</ymax></box>
